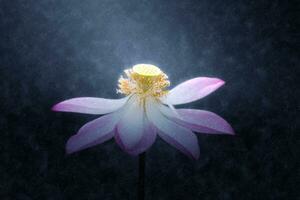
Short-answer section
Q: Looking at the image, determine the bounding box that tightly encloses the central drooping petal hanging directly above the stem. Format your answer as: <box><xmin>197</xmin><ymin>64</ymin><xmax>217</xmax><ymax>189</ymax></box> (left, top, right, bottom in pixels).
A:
<box><xmin>116</xmin><ymin>102</ymin><xmax>154</xmax><ymax>154</ymax></box>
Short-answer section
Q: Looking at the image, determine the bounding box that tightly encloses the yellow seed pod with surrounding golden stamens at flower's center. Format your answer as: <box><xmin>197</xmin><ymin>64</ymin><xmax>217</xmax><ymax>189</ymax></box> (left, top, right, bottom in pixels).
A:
<box><xmin>117</xmin><ymin>64</ymin><xmax>170</xmax><ymax>98</ymax></box>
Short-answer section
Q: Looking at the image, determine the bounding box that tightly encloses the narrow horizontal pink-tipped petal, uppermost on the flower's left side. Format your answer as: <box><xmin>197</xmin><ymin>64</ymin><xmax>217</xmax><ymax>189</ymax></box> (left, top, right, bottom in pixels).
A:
<box><xmin>52</xmin><ymin>97</ymin><xmax>128</xmax><ymax>115</ymax></box>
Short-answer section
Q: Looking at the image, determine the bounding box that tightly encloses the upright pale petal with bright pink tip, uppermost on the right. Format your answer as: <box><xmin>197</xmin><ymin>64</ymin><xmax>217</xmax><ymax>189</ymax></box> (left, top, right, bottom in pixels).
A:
<box><xmin>161</xmin><ymin>77</ymin><xmax>225</xmax><ymax>105</ymax></box>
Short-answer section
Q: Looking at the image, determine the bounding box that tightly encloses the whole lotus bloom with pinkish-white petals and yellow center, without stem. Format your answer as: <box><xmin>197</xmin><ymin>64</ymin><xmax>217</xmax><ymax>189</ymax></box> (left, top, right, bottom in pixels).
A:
<box><xmin>52</xmin><ymin>64</ymin><xmax>234</xmax><ymax>159</ymax></box>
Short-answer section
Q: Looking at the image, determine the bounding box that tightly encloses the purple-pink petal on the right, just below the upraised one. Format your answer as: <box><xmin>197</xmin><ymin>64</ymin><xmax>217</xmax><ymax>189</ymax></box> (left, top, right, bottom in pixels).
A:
<box><xmin>176</xmin><ymin>109</ymin><xmax>234</xmax><ymax>135</ymax></box>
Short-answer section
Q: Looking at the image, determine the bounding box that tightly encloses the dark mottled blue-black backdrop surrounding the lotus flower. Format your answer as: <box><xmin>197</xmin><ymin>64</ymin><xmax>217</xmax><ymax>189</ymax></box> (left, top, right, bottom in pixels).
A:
<box><xmin>0</xmin><ymin>0</ymin><xmax>300</xmax><ymax>200</ymax></box>
